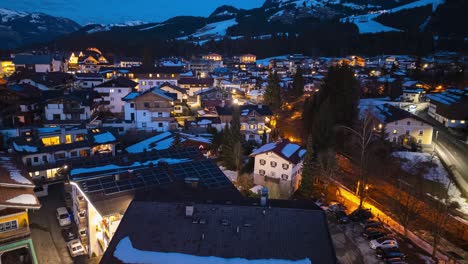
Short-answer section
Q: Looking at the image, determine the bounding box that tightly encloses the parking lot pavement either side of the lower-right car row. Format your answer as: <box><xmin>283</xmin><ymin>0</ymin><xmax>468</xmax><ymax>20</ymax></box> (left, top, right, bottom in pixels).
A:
<box><xmin>327</xmin><ymin>206</ymin><xmax>435</xmax><ymax>264</ymax></box>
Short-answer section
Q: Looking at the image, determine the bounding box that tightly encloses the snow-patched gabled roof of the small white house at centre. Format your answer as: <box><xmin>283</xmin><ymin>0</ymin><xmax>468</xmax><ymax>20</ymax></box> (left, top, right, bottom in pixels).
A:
<box><xmin>250</xmin><ymin>140</ymin><xmax>306</xmax><ymax>164</ymax></box>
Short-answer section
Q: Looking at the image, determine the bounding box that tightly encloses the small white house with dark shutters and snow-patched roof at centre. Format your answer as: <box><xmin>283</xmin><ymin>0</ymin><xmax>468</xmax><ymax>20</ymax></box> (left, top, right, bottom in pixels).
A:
<box><xmin>250</xmin><ymin>140</ymin><xmax>306</xmax><ymax>197</ymax></box>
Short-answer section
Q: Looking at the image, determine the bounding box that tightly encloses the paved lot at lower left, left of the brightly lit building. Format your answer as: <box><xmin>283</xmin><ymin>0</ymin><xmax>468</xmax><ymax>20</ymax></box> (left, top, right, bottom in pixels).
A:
<box><xmin>29</xmin><ymin>184</ymin><xmax>85</xmax><ymax>264</ymax></box>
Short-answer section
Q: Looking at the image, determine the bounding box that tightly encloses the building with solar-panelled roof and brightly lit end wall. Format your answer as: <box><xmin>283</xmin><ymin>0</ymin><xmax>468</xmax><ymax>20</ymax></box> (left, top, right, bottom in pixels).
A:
<box><xmin>69</xmin><ymin>148</ymin><xmax>239</xmax><ymax>256</ymax></box>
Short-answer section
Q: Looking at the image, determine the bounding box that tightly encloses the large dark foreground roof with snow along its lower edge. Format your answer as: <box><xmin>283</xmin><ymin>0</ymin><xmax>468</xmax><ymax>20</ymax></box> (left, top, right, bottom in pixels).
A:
<box><xmin>101</xmin><ymin>200</ymin><xmax>336</xmax><ymax>264</ymax></box>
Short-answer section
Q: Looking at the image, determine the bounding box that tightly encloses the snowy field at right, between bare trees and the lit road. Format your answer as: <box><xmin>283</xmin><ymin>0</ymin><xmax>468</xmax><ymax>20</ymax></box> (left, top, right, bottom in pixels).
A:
<box><xmin>393</xmin><ymin>151</ymin><xmax>468</xmax><ymax>215</ymax></box>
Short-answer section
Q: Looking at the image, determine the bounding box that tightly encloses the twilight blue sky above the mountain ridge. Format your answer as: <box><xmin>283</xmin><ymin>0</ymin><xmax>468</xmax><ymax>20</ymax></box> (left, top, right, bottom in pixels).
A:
<box><xmin>0</xmin><ymin>0</ymin><xmax>265</xmax><ymax>25</ymax></box>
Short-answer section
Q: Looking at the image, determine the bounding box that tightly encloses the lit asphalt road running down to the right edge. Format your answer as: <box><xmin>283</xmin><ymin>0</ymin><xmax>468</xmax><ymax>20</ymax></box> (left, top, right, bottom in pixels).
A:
<box><xmin>417</xmin><ymin>112</ymin><xmax>468</xmax><ymax>195</ymax></box>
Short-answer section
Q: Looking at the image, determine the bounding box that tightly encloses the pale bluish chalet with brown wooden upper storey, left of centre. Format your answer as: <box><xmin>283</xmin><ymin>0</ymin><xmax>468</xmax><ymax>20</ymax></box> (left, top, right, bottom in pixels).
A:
<box><xmin>123</xmin><ymin>87</ymin><xmax>177</xmax><ymax>132</ymax></box>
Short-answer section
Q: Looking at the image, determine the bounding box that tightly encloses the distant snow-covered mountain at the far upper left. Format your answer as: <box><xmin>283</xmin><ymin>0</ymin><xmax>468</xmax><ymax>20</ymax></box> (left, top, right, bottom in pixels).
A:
<box><xmin>0</xmin><ymin>8</ymin><xmax>80</xmax><ymax>49</ymax></box>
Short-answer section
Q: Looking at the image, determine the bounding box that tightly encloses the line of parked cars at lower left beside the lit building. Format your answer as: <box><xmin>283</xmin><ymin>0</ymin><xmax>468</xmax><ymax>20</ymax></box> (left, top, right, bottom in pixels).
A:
<box><xmin>55</xmin><ymin>207</ymin><xmax>86</xmax><ymax>258</ymax></box>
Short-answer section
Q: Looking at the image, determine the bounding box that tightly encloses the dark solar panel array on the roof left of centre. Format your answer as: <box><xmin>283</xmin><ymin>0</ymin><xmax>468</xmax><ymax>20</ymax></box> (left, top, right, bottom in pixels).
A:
<box><xmin>78</xmin><ymin>159</ymin><xmax>231</xmax><ymax>194</ymax></box>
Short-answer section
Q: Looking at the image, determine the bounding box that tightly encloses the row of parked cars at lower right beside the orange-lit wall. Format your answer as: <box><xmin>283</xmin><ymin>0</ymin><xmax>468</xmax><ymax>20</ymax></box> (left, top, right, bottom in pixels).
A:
<box><xmin>317</xmin><ymin>202</ymin><xmax>406</xmax><ymax>264</ymax></box>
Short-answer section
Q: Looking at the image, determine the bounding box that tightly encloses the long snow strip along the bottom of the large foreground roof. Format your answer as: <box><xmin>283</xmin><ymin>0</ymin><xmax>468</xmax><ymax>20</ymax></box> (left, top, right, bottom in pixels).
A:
<box><xmin>114</xmin><ymin>237</ymin><xmax>312</xmax><ymax>264</ymax></box>
